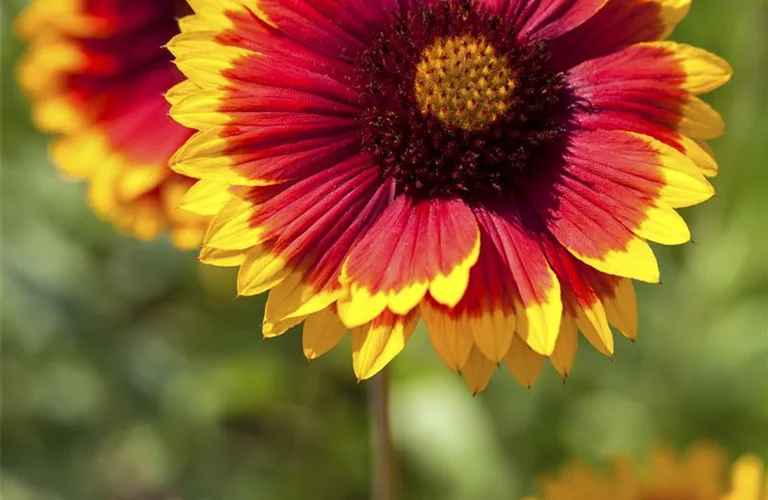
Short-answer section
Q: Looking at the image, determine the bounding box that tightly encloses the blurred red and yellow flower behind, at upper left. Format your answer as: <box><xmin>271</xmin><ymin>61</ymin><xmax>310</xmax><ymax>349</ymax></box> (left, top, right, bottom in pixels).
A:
<box><xmin>16</xmin><ymin>0</ymin><xmax>207</xmax><ymax>248</ymax></box>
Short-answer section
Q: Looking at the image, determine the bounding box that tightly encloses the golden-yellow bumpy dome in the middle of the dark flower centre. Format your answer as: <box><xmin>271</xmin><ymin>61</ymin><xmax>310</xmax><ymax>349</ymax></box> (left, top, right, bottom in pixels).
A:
<box><xmin>415</xmin><ymin>35</ymin><xmax>515</xmax><ymax>132</ymax></box>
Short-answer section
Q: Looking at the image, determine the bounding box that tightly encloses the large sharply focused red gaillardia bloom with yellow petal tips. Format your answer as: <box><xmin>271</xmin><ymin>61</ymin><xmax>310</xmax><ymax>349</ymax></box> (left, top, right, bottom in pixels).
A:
<box><xmin>169</xmin><ymin>0</ymin><xmax>731</xmax><ymax>391</ymax></box>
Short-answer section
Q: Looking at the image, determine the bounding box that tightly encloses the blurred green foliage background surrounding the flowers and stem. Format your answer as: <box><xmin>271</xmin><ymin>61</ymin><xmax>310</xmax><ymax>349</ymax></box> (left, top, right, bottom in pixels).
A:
<box><xmin>0</xmin><ymin>0</ymin><xmax>768</xmax><ymax>500</ymax></box>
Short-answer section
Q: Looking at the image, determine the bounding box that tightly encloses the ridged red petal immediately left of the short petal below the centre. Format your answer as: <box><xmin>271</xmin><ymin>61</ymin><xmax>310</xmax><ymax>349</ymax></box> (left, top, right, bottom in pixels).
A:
<box><xmin>255</xmin><ymin>157</ymin><xmax>390</xmax><ymax>323</ymax></box>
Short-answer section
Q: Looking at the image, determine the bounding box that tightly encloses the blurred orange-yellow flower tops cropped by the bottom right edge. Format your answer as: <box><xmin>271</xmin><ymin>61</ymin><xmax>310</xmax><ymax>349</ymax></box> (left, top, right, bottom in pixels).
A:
<box><xmin>528</xmin><ymin>444</ymin><xmax>768</xmax><ymax>500</ymax></box>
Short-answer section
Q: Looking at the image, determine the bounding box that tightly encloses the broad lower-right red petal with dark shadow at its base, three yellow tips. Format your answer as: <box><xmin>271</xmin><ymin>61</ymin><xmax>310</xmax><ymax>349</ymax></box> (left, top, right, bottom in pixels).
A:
<box><xmin>528</xmin><ymin>131</ymin><xmax>714</xmax><ymax>282</ymax></box>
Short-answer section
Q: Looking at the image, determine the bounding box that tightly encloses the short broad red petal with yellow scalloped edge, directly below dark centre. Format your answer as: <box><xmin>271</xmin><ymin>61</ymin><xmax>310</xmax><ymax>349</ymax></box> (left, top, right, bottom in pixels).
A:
<box><xmin>339</xmin><ymin>195</ymin><xmax>480</xmax><ymax>327</ymax></box>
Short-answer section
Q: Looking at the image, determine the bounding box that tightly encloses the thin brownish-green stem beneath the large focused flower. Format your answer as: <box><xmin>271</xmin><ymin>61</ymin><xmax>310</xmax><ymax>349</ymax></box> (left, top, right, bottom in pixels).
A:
<box><xmin>369</xmin><ymin>367</ymin><xmax>397</xmax><ymax>500</ymax></box>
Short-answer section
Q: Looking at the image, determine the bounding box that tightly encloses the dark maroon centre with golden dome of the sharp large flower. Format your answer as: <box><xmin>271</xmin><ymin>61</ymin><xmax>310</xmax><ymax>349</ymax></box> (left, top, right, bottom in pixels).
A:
<box><xmin>355</xmin><ymin>0</ymin><xmax>574</xmax><ymax>203</ymax></box>
